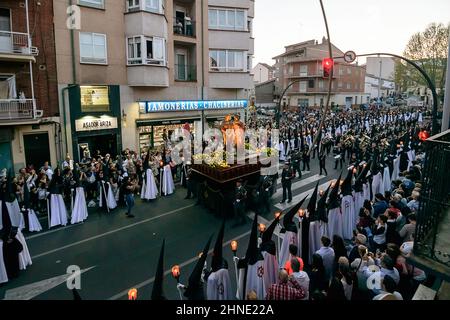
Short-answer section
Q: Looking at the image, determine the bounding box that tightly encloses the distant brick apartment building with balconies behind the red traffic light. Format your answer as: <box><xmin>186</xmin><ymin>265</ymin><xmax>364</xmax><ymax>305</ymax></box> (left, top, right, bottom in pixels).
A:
<box><xmin>274</xmin><ymin>38</ymin><xmax>368</xmax><ymax>108</ymax></box>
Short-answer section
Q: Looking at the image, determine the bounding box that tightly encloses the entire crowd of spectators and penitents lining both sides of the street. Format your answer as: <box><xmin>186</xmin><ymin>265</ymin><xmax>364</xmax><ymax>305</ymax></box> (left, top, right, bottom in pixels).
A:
<box><xmin>0</xmin><ymin>104</ymin><xmax>429</xmax><ymax>300</ymax></box>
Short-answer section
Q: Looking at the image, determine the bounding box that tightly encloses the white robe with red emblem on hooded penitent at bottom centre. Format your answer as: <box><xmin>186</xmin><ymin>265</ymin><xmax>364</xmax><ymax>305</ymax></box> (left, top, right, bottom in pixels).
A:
<box><xmin>236</xmin><ymin>260</ymin><xmax>266</xmax><ymax>300</ymax></box>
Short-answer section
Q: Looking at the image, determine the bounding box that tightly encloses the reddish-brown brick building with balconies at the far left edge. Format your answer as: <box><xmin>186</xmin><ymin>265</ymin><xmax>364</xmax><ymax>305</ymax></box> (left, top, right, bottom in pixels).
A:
<box><xmin>0</xmin><ymin>0</ymin><xmax>61</xmax><ymax>171</ymax></box>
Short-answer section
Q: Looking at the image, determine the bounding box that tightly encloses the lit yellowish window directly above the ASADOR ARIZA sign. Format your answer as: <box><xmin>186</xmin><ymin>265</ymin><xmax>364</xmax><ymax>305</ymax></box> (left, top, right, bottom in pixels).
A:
<box><xmin>80</xmin><ymin>86</ymin><xmax>110</xmax><ymax>112</ymax></box>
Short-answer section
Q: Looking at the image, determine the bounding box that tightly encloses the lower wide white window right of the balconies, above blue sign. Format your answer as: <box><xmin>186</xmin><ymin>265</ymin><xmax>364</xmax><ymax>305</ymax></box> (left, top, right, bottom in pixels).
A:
<box><xmin>209</xmin><ymin>50</ymin><xmax>248</xmax><ymax>72</ymax></box>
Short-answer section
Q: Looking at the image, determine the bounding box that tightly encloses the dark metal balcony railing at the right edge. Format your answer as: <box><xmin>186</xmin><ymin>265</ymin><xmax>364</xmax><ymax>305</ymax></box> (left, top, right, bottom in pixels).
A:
<box><xmin>414</xmin><ymin>130</ymin><xmax>450</xmax><ymax>267</ymax></box>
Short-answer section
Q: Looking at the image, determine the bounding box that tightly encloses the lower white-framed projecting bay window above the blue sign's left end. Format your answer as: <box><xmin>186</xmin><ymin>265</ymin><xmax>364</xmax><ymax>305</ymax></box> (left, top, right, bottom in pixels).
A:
<box><xmin>127</xmin><ymin>36</ymin><xmax>166</xmax><ymax>66</ymax></box>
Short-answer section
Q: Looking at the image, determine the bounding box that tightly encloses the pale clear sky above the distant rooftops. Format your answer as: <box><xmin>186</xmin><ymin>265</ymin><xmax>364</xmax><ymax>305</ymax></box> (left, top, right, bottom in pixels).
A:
<box><xmin>253</xmin><ymin>0</ymin><xmax>450</xmax><ymax>65</ymax></box>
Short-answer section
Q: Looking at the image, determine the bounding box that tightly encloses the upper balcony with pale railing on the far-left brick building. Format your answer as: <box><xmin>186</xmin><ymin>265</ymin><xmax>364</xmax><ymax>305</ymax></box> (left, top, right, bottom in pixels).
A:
<box><xmin>0</xmin><ymin>31</ymin><xmax>38</xmax><ymax>61</ymax></box>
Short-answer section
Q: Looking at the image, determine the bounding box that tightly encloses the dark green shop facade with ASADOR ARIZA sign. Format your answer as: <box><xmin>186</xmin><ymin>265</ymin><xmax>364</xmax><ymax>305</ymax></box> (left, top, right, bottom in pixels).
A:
<box><xmin>68</xmin><ymin>85</ymin><xmax>122</xmax><ymax>161</ymax></box>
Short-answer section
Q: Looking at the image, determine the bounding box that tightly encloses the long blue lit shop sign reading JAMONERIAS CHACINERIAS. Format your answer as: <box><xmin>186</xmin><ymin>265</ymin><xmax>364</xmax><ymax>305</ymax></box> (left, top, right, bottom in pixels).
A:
<box><xmin>139</xmin><ymin>100</ymin><xmax>248</xmax><ymax>113</ymax></box>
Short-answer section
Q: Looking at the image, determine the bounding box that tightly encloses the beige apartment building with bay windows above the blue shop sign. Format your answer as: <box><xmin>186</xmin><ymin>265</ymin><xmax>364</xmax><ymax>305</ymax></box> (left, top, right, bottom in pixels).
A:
<box><xmin>54</xmin><ymin>0</ymin><xmax>254</xmax><ymax>159</ymax></box>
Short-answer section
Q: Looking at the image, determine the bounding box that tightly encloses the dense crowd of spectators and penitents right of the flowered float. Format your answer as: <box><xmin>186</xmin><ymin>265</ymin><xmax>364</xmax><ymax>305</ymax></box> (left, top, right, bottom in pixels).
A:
<box><xmin>162</xmin><ymin>107</ymin><xmax>429</xmax><ymax>301</ymax></box>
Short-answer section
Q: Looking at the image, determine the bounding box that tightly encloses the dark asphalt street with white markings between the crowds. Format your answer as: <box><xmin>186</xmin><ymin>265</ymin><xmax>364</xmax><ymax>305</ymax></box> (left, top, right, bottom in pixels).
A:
<box><xmin>0</xmin><ymin>154</ymin><xmax>340</xmax><ymax>300</ymax></box>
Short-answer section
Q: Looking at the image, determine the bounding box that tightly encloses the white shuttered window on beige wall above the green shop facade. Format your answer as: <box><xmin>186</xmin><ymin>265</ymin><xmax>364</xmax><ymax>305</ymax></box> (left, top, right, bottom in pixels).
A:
<box><xmin>80</xmin><ymin>32</ymin><xmax>108</xmax><ymax>64</ymax></box>
